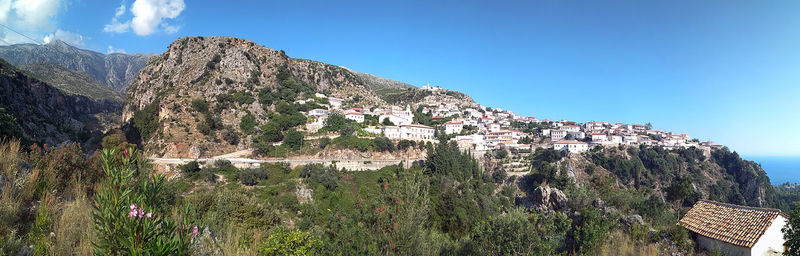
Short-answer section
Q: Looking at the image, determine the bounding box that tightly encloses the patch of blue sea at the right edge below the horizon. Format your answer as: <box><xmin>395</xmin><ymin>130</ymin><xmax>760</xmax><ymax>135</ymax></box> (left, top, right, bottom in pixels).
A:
<box><xmin>742</xmin><ymin>156</ymin><xmax>800</xmax><ymax>185</ymax></box>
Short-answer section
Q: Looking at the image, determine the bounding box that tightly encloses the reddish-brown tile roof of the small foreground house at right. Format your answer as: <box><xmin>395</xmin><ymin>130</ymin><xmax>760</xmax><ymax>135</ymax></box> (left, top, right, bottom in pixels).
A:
<box><xmin>678</xmin><ymin>200</ymin><xmax>781</xmax><ymax>247</ymax></box>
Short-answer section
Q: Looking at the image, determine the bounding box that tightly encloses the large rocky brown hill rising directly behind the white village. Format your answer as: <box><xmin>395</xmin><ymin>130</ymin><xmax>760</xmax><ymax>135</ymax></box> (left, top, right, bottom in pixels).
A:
<box><xmin>123</xmin><ymin>37</ymin><xmax>475</xmax><ymax>157</ymax></box>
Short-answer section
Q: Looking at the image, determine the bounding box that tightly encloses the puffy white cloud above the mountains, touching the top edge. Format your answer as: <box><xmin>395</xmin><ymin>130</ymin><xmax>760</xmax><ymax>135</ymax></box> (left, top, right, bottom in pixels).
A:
<box><xmin>106</xmin><ymin>0</ymin><xmax>186</xmax><ymax>36</ymax></box>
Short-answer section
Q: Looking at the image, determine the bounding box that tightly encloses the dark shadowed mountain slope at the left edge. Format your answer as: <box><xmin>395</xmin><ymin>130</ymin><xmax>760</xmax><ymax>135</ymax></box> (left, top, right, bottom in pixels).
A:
<box><xmin>0</xmin><ymin>57</ymin><xmax>119</xmax><ymax>145</ymax></box>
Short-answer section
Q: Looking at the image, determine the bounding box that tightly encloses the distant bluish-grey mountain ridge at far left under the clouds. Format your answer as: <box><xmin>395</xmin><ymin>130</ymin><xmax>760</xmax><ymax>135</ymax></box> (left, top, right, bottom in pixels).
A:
<box><xmin>0</xmin><ymin>40</ymin><xmax>153</xmax><ymax>91</ymax></box>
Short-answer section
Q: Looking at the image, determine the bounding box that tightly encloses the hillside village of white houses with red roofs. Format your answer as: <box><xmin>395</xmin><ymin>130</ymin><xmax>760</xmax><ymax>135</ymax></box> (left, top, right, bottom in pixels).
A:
<box><xmin>295</xmin><ymin>85</ymin><xmax>708</xmax><ymax>155</ymax></box>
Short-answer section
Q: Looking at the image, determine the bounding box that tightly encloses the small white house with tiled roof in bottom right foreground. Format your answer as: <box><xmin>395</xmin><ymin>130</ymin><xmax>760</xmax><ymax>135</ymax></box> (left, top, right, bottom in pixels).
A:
<box><xmin>678</xmin><ymin>200</ymin><xmax>788</xmax><ymax>256</ymax></box>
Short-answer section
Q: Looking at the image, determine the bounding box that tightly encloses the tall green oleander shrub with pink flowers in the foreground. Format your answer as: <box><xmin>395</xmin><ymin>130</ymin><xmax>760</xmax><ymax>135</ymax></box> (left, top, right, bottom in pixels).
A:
<box><xmin>92</xmin><ymin>150</ymin><xmax>197</xmax><ymax>255</ymax></box>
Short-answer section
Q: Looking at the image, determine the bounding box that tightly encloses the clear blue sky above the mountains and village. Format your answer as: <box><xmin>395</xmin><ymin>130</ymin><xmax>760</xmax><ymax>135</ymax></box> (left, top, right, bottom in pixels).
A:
<box><xmin>0</xmin><ymin>0</ymin><xmax>800</xmax><ymax>156</ymax></box>
